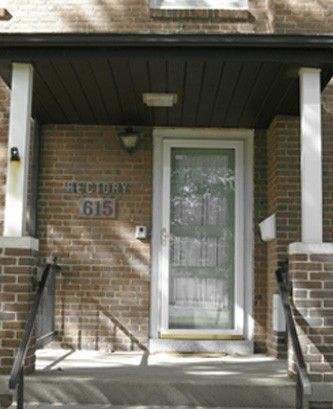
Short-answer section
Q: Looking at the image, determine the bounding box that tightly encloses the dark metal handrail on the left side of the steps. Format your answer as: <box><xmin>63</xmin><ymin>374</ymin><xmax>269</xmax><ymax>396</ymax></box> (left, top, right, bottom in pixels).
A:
<box><xmin>9</xmin><ymin>264</ymin><xmax>53</xmax><ymax>409</ymax></box>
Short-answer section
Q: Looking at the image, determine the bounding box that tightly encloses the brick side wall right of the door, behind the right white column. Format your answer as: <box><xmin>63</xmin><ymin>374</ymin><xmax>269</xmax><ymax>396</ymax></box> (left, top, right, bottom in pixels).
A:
<box><xmin>267</xmin><ymin>103</ymin><xmax>333</xmax><ymax>356</ymax></box>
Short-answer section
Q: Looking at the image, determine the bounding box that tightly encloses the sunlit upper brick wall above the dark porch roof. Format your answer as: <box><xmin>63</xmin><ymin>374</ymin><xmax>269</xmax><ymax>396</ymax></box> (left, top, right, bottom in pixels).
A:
<box><xmin>0</xmin><ymin>0</ymin><xmax>333</xmax><ymax>33</ymax></box>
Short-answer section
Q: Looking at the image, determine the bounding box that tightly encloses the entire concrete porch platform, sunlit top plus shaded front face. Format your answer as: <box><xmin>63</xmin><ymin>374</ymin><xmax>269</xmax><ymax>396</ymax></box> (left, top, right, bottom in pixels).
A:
<box><xmin>12</xmin><ymin>350</ymin><xmax>295</xmax><ymax>409</ymax></box>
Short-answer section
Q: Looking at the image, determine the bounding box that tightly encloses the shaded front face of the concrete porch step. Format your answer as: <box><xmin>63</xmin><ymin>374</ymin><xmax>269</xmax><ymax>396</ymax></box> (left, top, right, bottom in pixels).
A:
<box><xmin>25</xmin><ymin>374</ymin><xmax>295</xmax><ymax>409</ymax></box>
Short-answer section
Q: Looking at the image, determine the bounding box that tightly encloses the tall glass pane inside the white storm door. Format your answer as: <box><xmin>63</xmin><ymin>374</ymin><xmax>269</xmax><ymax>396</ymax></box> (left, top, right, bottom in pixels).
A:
<box><xmin>168</xmin><ymin>148</ymin><xmax>235</xmax><ymax>330</ymax></box>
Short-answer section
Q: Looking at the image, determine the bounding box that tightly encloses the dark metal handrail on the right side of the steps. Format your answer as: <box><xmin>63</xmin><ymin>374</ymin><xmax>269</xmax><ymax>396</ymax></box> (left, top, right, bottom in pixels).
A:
<box><xmin>275</xmin><ymin>267</ymin><xmax>312</xmax><ymax>409</ymax></box>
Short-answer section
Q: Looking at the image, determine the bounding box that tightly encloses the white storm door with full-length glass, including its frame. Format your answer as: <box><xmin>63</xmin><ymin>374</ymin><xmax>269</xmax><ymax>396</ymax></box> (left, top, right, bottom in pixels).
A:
<box><xmin>160</xmin><ymin>140</ymin><xmax>244</xmax><ymax>335</ymax></box>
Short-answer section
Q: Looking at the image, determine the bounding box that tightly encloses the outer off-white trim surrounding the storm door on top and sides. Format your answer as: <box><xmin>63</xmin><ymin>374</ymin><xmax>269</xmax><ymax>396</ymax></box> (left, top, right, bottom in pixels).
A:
<box><xmin>150</xmin><ymin>128</ymin><xmax>254</xmax><ymax>343</ymax></box>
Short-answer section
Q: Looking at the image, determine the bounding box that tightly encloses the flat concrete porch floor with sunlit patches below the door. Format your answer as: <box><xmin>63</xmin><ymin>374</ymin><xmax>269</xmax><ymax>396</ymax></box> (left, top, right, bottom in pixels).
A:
<box><xmin>34</xmin><ymin>348</ymin><xmax>294</xmax><ymax>386</ymax></box>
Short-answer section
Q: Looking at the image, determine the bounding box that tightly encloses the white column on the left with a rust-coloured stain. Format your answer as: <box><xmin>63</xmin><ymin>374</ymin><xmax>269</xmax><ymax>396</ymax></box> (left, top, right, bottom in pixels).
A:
<box><xmin>4</xmin><ymin>63</ymin><xmax>33</xmax><ymax>237</ymax></box>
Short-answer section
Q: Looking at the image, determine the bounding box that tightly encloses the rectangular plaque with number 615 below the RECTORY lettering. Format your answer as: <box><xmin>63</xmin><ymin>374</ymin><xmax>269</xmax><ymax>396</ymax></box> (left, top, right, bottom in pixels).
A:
<box><xmin>80</xmin><ymin>198</ymin><xmax>116</xmax><ymax>219</ymax></box>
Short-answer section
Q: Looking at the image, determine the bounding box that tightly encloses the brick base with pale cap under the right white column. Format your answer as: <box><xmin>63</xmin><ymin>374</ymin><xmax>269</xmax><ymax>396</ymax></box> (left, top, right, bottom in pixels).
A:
<box><xmin>289</xmin><ymin>243</ymin><xmax>333</xmax><ymax>382</ymax></box>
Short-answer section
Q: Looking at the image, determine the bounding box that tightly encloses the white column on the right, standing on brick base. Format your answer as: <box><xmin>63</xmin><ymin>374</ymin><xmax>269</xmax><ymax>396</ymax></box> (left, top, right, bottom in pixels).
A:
<box><xmin>299</xmin><ymin>68</ymin><xmax>323</xmax><ymax>243</ymax></box>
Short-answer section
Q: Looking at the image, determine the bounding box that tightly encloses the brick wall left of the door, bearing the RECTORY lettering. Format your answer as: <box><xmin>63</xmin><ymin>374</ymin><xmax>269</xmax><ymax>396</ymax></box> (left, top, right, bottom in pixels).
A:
<box><xmin>38</xmin><ymin>125</ymin><xmax>152</xmax><ymax>350</ymax></box>
